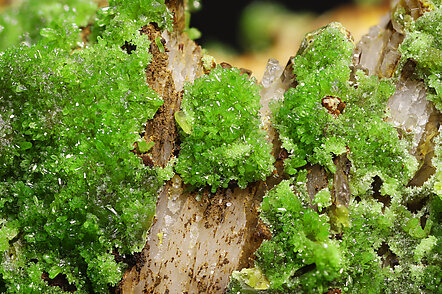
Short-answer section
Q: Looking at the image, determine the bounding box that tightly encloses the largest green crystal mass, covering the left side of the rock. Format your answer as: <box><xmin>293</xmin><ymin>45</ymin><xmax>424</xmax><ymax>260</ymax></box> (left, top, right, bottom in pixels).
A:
<box><xmin>0</xmin><ymin>1</ymin><xmax>171</xmax><ymax>293</ymax></box>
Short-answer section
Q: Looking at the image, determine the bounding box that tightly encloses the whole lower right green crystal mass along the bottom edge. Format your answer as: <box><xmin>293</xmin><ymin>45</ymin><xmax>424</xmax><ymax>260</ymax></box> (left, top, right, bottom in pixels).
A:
<box><xmin>243</xmin><ymin>168</ymin><xmax>442</xmax><ymax>294</ymax></box>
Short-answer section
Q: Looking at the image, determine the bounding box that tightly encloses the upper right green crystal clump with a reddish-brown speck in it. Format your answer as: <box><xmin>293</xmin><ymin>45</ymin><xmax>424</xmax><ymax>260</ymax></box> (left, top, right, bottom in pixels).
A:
<box><xmin>275</xmin><ymin>23</ymin><xmax>416</xmax><ymax>188</ymax></box>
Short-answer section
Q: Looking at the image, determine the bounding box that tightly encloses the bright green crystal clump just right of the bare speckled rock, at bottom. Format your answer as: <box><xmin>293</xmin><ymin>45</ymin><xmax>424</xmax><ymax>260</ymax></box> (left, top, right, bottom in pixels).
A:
<box><xmin>256</xmin><ymin>181</ymin><xmax>342</xmax><ymax>293</ymax></box>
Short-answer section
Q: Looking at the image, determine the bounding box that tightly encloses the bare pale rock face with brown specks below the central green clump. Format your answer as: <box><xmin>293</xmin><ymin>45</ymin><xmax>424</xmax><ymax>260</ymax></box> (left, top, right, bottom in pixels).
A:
<box><xmin>121</xmin><ymin>176</ymin><xmax>263</xmax><ymax>293</ymax></box>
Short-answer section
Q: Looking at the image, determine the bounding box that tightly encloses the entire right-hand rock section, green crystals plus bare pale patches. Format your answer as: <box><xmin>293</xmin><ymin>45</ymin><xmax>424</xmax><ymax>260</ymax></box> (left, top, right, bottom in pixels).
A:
<box><xmin>230</xmin><ymin>1</ymin><xmax>442</xmax><ymax>293</ymax></box>
